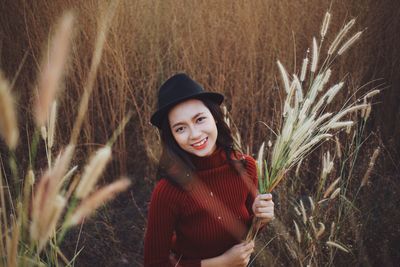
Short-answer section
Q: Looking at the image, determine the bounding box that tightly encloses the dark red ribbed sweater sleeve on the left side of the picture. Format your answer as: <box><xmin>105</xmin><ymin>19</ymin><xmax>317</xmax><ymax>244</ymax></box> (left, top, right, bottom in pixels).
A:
<box><xmin>144</xmin><ymin>179</ymin><xmax>200</xmax><ymax>267</ymax></box>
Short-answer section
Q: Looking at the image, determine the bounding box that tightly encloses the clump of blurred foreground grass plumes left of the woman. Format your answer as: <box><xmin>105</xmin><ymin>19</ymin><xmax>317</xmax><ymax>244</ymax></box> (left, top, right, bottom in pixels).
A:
<box><xmin>0</xmin><ymin>9</ymin><xmax>131</xmax><ymax>267</ymax></box>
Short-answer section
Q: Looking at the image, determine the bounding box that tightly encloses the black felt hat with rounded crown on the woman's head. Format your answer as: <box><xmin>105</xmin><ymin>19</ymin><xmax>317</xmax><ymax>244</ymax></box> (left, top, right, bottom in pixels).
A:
<box><xmin>150</xmin><ymin>73</ymin><xmax>224</xmax><ymax>128</ymax></box>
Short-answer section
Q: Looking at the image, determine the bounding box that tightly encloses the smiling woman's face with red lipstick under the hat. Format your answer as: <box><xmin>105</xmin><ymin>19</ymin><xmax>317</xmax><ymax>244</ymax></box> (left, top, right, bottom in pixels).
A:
<box><xmin>168</xmin><ymin>99</ymin><xmax>218</xmax><ymax>157</ymax></box>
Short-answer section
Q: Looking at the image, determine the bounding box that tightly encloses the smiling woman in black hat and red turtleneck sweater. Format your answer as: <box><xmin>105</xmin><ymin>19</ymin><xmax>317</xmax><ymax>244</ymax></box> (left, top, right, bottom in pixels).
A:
<box><xmin>144</xmin><ymin>73</ymin><xmax>274</xmax><ymax>267</ymax></box>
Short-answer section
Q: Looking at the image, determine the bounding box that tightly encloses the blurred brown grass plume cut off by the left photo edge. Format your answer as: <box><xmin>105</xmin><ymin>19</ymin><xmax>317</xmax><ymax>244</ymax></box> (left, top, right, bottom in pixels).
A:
<box><xmin>0</xmin><ymin>72</ymin><xmax>19</xmax><ymax>150</ymax></box>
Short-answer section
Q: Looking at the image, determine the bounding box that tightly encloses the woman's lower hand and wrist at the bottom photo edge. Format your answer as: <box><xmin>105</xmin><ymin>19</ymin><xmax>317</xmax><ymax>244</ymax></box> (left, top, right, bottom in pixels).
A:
<box><xmin>201</xmin><ymin>241</ymin><xmax>254</xmax><ymax>267</ymax></box>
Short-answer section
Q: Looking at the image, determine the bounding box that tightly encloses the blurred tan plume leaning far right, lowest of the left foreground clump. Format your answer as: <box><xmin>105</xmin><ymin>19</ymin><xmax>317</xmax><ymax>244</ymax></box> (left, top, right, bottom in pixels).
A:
<box><xmin>66</xmin><ymin>178</ymin><xmax>131</xmax><ymax>226</ymax></box>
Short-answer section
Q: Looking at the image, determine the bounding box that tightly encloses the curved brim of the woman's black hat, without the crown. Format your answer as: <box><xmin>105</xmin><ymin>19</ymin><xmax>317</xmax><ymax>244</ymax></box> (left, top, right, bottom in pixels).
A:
<box><xmin>150</xmin><ymin>92</ymin><xmax>224</xmax><ymax>128</ymax></box>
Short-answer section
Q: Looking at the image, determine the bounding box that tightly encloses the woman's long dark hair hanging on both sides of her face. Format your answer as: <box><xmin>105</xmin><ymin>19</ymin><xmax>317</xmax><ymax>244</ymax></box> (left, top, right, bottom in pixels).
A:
<box><xmin>157</xmin><ymin>98</ymin><xmax>246</xmax><ymax>188</ymax></box>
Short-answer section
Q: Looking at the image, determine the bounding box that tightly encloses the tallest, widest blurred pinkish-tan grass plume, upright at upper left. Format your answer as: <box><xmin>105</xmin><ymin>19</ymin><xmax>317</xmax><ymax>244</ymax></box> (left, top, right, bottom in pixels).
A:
<box><xmin>35</xmin><ymin>13</ymin><xmax>74</xmax><ymax>127</ymax></box>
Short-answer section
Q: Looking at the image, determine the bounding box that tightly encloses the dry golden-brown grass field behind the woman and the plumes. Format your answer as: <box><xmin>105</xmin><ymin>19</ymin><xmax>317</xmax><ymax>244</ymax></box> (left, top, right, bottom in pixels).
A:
<box><xmin>0</xmin><ymin>0</ymin><xmax>400</xmax><ymax>266</ymax></box>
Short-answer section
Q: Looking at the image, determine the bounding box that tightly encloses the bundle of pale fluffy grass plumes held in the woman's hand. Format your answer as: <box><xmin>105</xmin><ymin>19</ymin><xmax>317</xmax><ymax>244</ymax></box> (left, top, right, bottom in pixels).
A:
<box><xmin>247</xmin><ymin>12</ymin><xmax>379</xmax><ymax>240</ymax></box>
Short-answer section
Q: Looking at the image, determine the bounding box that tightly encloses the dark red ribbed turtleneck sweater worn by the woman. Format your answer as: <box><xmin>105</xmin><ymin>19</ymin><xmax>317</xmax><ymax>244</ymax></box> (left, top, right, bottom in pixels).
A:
<box><xmin>144</xmin><ymin>149</ymin><xmax>257</xmax><ymax>267</ymax></box>
